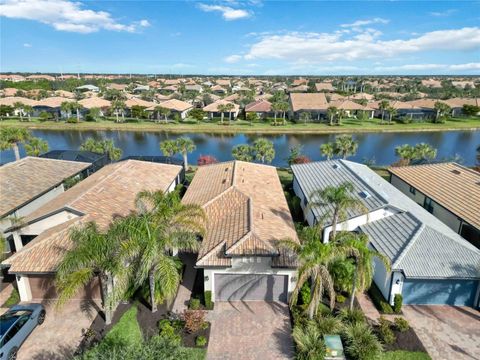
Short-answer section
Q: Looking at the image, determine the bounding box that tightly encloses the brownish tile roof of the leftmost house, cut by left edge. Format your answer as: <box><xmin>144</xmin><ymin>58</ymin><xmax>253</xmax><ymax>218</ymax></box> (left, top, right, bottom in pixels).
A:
<box><xmin>0</xmin><ymin>157</ymin><xmax>91</xmax><ymax>216</ymax></box>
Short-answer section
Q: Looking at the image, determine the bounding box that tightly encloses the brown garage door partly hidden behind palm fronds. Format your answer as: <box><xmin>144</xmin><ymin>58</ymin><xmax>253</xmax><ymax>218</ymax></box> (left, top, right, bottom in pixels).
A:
<box><xmin>28</xmin><ymin>275</ymin><xmax>101</xmax><ymax>300</ymax></box>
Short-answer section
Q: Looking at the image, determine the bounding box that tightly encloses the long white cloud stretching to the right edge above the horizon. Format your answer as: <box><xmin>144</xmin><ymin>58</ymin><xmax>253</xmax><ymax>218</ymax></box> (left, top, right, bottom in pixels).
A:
<box><xmin>244</xmin><ymin>27</ymin><xmax>480</xmax><ymax>64</ymax></box>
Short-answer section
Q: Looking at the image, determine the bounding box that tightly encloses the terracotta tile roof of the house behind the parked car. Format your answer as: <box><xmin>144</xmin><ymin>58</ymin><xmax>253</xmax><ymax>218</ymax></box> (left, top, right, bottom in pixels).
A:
<box><xmin>3</xmin><ymin>160</ymin><xmax>182</xmax><ymax>273</ymax></box>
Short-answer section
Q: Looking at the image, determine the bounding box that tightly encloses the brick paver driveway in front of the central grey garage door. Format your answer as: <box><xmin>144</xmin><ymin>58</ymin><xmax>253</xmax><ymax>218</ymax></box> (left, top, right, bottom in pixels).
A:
<box><xmin>207</xmin><ymin>301</ymin><xmax>293</xmax><ymax>360</ymax></box>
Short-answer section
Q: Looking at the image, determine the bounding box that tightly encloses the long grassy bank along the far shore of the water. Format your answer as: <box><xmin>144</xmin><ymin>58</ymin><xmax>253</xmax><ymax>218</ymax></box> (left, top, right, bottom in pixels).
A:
<box><xmin>0</xmin><ymin>117</ymin><xmax>480</xmax><ymax>134</ymax></box>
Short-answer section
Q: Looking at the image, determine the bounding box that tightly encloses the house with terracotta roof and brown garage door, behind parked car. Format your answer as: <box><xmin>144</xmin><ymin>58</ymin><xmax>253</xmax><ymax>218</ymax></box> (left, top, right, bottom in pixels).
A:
<box><xmin>2</xmin><ymin>159</ymin><xmax>182</xmax><ymax>301</ymax></box>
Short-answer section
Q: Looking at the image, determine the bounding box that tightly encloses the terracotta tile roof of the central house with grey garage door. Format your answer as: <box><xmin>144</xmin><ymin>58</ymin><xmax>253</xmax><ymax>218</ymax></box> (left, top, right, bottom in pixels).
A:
<box><xmin>183</xmin><ymin>161</ymin><xmax>298</xmax><ymax>267</ymax></box>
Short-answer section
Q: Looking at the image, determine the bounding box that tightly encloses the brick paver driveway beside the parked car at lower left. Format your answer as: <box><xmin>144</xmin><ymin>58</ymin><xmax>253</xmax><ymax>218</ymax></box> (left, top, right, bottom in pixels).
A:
<box><xmin>17</xmin><ymin>301</ymin><xmax>97</xmax><ymax>360</ymax></box>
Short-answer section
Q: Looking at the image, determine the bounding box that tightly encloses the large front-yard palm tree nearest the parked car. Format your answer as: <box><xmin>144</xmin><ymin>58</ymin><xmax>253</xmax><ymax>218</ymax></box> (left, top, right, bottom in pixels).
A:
<box><xmin>56</xmin><ymin>222</ymin><xmax>126</xmax><ymax>325</ymax></box>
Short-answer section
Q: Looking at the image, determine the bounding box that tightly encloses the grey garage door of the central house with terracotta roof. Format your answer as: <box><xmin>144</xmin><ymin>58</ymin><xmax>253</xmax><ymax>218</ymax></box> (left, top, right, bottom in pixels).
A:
<box><xmin>214</xmin><ymin>274</ymin><xmax>288</xmax><ymax>302</ymax></box>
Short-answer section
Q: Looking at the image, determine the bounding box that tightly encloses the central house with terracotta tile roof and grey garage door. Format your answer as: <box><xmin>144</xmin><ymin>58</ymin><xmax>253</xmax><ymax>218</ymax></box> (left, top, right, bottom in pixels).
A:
<box><xmin>182</xmin><ymin>161</ymin><xmax>298</xmax><ymax>302</ymax></box>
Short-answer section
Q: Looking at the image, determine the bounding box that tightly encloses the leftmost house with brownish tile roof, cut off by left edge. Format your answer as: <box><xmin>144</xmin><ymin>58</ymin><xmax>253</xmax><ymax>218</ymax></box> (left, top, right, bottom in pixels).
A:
<box><xmin>0</xmin><ymin>156</ymin><xmax>91</xmax><ymax>253</ymax></box>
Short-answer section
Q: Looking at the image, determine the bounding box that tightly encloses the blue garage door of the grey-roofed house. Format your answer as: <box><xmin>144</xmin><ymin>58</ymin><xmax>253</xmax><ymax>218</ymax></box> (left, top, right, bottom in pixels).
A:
<box><xmin>402</xmin><ymin>279</ymin><xmax>478</xmax><ymax>306</ymax></box>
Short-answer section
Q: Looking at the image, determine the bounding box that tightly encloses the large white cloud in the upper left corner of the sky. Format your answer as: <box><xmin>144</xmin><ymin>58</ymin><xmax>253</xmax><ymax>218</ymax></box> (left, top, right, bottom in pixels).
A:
<box><xmin>0</xmin><ymin>0</ymin><xmax>150</xmax><ymax>34</ymax></box>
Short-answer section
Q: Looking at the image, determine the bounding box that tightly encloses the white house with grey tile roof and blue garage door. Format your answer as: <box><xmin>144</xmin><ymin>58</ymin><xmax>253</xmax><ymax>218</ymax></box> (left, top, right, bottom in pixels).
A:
<box><xmin>292</xmin><ymin>160</ymin><xmax>480</xmax><ymax>307</ymax></box>
